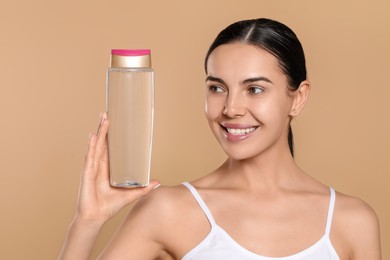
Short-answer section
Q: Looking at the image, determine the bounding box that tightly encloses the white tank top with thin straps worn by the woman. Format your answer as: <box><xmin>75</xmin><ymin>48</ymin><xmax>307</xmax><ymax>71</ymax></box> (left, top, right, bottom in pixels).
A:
<box><xmin>183</xmin><ymin>182</ymin><xmax>340</xmax><ymax>260</ymax></box>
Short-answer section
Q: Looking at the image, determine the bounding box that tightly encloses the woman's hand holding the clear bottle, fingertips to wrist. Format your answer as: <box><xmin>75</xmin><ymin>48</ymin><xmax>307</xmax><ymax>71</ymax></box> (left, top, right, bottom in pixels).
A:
<box><xmin>76</xmin><ymin>113</ymin><xmax>159</xmax><ymax>223</ymax></box>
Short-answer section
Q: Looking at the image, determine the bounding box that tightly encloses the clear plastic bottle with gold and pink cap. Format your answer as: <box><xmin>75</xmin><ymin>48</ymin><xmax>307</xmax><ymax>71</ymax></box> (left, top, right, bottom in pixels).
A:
<box><xmin>106</xmin><ymin>49</ymin><xmax>154</xmax><ymax>188</ymax></box>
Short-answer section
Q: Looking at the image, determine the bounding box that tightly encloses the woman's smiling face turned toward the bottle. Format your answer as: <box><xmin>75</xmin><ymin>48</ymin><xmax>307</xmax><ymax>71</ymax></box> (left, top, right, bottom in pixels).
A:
<box><xmin>205</xmin><ymin>43</ymin><xmax>293</xmax><ymax>160</ymax></box>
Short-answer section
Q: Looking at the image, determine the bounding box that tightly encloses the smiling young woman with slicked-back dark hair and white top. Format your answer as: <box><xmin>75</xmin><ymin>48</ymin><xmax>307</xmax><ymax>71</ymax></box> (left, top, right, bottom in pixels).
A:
<box><xmin>60</xmin><ymin>19</ymin><xmax>381</xmax><ymax>260</ymax></box>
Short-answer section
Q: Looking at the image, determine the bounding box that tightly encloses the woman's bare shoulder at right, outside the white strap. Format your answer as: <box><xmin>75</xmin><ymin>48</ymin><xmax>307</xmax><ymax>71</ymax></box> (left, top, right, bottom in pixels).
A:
<box><xmin>332</xmin><ymin>192</ymin><xmax>380</xmax><ymax>259</ymax></box>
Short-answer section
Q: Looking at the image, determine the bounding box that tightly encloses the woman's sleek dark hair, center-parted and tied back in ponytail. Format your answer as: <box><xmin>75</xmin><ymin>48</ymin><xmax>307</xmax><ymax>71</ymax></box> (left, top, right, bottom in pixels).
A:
<box><xmin>204</xmin><ymin>18</ymin><xmax>306</xmax><ymax>156</ymax></box>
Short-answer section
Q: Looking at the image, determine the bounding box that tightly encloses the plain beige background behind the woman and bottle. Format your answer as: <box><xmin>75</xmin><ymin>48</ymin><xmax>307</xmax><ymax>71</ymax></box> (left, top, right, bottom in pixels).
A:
<box><xmin>0</xmin><ymin>0</ymin><xmax>390</xmax><ymax>259</ymax></box>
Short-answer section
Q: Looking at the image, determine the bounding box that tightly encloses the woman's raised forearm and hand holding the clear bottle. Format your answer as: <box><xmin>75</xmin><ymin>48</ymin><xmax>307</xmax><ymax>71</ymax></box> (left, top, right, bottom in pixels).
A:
<box><xmin>58</xmin><ymin>114</ymin><xmax>159</xmax><ymax>260</ymax></box>
